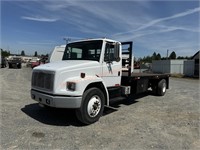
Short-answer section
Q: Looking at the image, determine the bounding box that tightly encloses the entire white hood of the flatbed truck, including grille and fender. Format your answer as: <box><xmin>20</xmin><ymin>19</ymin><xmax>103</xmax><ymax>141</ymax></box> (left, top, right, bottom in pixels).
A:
<box><xmin>32</xmin><ymin>60</ymin><xmax>102</xmax><ymax>96</ymax></box>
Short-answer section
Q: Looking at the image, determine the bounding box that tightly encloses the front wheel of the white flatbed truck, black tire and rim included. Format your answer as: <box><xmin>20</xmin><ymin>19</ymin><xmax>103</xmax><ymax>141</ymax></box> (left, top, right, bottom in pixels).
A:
<box><xmin>76</xmin><ymin>88</ymin><xmax>105</xmax><ymax>125</ymax></box>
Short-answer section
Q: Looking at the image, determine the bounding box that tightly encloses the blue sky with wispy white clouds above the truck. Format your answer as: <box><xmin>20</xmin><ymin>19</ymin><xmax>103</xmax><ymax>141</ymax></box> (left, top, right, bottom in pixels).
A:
<box><xmin>0</xmin><ymin>0</ymin><xmax>200</xmax><ymax>58</ymax></box>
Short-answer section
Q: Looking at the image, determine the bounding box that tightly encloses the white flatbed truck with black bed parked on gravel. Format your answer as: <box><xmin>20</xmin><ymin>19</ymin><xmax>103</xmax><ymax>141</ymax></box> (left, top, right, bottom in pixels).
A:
<box><xmin>31</xmin><ymin>38</ymin><xmax>169</xmax><ymax>124</ymax></box>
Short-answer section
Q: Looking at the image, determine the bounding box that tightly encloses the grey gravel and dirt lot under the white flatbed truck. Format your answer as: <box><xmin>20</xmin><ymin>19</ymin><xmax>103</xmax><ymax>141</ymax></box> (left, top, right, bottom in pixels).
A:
<box><xmin>0</xmin><ymin>68</ymin><xmax>200</xmax><ymax>150</ymax></box>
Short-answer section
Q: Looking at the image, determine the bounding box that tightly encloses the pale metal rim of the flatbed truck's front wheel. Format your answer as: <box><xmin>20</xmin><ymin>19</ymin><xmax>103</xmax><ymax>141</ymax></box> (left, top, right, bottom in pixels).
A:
<box><xmin>87</xmin><ymin>95</ymin><xmax>101</xmax><ymax>117</ymax></box>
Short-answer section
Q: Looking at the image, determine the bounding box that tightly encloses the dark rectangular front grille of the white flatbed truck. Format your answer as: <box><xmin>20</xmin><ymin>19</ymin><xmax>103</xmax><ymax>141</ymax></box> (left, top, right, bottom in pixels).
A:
<box><xmin>32</xmin><ymin>71</ymin><xmax>54</xmax><ymax>91</ymax></box>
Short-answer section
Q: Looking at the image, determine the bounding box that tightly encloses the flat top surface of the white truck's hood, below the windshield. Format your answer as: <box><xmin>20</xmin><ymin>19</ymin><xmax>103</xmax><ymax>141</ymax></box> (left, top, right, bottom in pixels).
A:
<box><xmin>34</xmin><ymin>60</ymin><xmax>99</xmax><ymax>72</ymax></box>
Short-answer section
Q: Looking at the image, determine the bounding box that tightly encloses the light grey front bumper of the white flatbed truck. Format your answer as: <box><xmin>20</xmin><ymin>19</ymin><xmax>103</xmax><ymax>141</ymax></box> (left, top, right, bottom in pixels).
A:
<box><xmin>31</xmin><ymin>90</ymin><xmax>82</xmax><ymax>108</ymax></box>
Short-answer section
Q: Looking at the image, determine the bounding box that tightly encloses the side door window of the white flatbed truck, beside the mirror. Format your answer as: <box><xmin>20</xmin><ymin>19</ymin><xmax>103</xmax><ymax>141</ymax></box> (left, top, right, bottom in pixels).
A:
<box><xmin>104</xmin><ymin>43</ymin><xmax>119</xmax><ymax>61</ymax></box>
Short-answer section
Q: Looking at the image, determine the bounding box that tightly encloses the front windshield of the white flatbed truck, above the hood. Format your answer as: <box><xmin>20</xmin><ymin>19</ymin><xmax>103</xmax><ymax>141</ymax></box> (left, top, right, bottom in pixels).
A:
<box><xmin>62</xmin><ymin>40</ymin><xmax>103</xmax><ymax>61</ymax></box>
